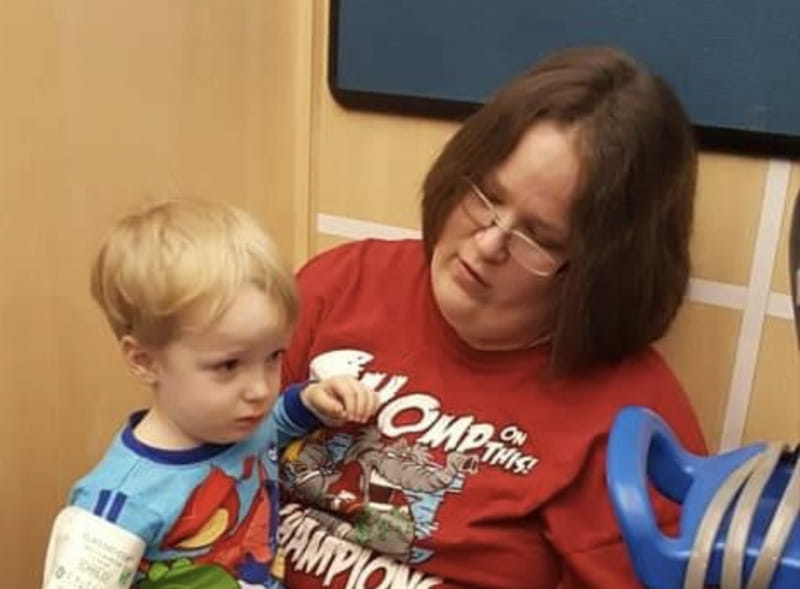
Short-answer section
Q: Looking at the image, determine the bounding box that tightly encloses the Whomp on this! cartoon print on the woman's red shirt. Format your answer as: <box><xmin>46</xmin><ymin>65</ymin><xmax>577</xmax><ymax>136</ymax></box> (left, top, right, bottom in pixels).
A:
<box><xmin>282</xmin><ymin>349</ymin><xmax>537</xmax><ymax>587</ymax></box>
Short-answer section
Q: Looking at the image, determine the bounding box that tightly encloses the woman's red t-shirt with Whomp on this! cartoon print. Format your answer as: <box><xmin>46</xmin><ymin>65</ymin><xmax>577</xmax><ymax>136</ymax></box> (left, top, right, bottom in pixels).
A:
<box><xmin>280</xmin><ymin>240</ymin><xmax>703</xmax><ymax>589</ymax></box>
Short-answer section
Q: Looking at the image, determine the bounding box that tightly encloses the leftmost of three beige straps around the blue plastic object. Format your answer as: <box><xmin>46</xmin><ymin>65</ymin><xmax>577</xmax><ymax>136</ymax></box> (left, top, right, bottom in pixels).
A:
<box><xmin>683</xmin><ymin>454</ymin><xmax>760</xmax><ymax>589</ymax></box>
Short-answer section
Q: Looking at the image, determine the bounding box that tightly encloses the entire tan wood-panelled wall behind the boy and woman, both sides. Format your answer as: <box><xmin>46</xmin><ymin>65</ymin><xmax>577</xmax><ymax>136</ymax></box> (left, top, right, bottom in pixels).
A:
<box><xmin>0</xmin><ymin>0</ymin><xmax>800</xmax><ymax>587</ymax></box>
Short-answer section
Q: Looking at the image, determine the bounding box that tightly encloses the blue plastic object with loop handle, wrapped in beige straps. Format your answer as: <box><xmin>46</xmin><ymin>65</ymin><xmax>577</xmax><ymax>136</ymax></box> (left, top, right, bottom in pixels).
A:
<box><xmin>607</xmin><ymin>407</ymin><xmax>800</xmax><ymax>589</ymax></box>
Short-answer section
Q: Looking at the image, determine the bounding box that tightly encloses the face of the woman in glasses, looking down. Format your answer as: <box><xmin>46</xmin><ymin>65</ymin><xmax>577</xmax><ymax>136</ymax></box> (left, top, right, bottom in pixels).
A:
<box><xmin>431</xmin><ymin>121</ymin><xmax>579</xmax><ymax>350</ymax></box>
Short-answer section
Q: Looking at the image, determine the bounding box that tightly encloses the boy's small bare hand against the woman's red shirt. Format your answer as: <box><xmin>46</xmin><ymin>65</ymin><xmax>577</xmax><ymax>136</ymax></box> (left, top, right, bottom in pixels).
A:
<box><xmin>300</xmin><ymin>376</ymin><xmax>378</xmax><ymax>426</ymax></box>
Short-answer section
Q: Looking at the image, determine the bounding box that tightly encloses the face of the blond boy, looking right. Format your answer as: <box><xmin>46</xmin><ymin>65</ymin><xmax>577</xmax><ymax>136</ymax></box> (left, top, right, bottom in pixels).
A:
<box><xmin>143</xmin><ymin>285</ymin><xmax>289</xmax><ymax>447</ymax></box>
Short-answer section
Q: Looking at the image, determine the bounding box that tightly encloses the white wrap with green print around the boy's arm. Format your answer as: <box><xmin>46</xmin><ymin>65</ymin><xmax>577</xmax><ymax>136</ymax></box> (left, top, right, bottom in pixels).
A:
<box><xmin>42</xmin><ymin>506</ymin><xmax>145</xmax><ymax>589</ymax></box>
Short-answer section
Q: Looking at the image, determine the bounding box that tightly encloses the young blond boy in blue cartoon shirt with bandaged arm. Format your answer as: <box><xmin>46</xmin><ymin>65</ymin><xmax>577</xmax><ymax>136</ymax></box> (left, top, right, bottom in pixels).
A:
<box><xmin>44</xmin><ymin>200</ymin><xmax>377</xmax><ymax>589</ymax></box>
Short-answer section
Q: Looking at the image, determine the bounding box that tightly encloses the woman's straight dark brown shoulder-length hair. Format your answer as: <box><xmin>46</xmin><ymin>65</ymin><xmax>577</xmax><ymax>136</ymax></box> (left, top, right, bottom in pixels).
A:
<box><xmin>422</xmin><ymin>48</ymin><xmax>697</xmax><ymax>375</ymax></box>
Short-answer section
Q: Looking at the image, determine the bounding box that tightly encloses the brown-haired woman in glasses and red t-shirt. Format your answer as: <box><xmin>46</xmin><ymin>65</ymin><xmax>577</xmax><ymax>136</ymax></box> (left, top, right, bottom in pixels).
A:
<box><xmin>281</xmin><ymin>48</ymin><xmax>703</xmax><ymax>589</ymax></box>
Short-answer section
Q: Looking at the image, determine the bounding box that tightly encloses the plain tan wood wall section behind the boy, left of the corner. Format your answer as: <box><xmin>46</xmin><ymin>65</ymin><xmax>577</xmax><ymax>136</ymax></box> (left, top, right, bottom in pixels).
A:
<box><xmin>0</xmin><ymin>0</ymin><xmax>312</xmax><ymax>588</ymax></box>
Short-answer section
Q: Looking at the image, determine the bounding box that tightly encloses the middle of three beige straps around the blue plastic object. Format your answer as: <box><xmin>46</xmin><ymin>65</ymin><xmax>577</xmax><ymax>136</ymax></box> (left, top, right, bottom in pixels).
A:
<box><xmin>721</xmin><ymin>443</ymin><xmax>784</xmax><ymax>589</ymax></box>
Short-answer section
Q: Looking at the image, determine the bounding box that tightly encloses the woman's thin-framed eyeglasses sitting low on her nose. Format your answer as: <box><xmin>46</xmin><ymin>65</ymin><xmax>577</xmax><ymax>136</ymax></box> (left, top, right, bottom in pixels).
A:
<box><xmin>461</xmin><ymin>176</ymin><xmax>564</xmax><ymax>277</ymax></box>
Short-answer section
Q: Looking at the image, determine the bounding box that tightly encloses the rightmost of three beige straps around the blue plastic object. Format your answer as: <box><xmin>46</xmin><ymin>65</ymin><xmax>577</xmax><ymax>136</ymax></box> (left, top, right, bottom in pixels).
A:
<box><xmin>747</xmin><ymin>460</ymin><xmax>800</xmax><ymax>589</ymax></box>
